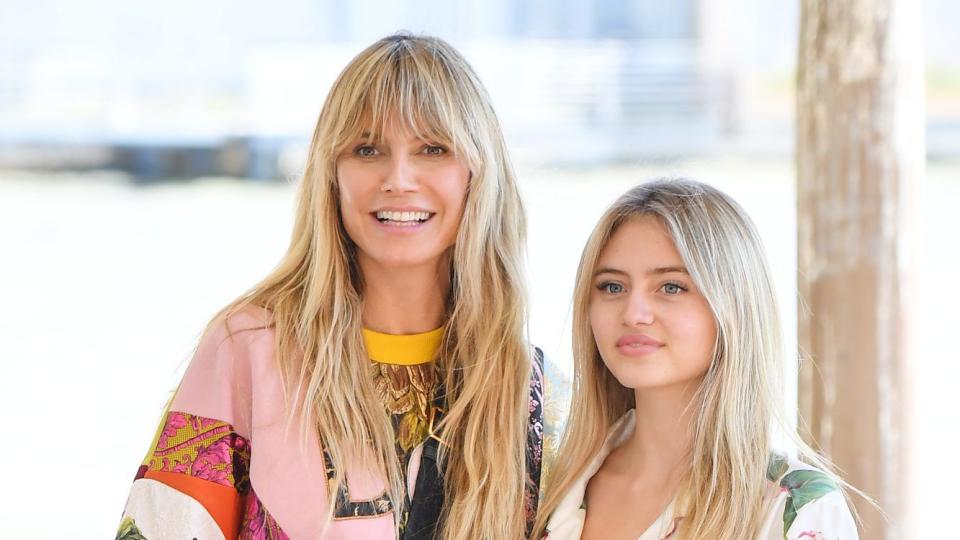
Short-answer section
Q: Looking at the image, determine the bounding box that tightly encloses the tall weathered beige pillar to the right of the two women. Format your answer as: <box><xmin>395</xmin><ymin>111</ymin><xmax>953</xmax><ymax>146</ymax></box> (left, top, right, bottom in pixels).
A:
<box><xmin>797</xmin><ymin>0</ymin><xmax>925</xmax><ymax>540</ymax></box>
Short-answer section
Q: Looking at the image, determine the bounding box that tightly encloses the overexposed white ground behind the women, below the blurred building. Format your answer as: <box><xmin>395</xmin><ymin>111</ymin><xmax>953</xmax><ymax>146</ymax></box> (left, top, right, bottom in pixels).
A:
<box><xmin>0</xmin><ymin>156</ymin><xmax>960</xmax><ymax>538</ymax></box>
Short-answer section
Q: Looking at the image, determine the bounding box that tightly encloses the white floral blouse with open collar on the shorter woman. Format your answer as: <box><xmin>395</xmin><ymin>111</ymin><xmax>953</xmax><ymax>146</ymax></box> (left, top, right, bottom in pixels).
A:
<box><xmin>545</xmin><ymin>410</ymin><xmax>859</xmax><ymax>540</ymax></box>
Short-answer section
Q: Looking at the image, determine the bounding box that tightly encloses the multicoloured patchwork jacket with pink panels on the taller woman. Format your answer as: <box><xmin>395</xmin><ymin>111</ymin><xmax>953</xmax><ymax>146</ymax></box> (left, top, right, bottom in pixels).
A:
<box><xmin>116</xmin><ymin>308</ymin><xmax>569</xmax><ymax>540</ymax></box>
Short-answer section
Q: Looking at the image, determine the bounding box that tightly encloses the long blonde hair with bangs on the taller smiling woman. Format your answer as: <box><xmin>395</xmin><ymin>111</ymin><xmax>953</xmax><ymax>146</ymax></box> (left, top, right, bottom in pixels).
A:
<box><xmin>214</xmin><ymin>34</ymin><xmax>531</xmax><ymax>540</ymax></box>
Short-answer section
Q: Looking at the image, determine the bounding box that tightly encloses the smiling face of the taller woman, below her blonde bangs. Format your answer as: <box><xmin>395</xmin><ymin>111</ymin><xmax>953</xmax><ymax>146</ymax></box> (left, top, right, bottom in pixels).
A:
<box><xmin>337</xmin><ymin>121</ymin><xmax>470</xmax><ymax>270</ymax></box>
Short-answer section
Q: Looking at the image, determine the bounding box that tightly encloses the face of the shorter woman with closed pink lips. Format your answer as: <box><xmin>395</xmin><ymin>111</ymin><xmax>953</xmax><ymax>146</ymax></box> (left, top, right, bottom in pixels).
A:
<box><xmin>590</xmin><ymin>216</ymin><xmax>717</xmax><ymax>390</ymax></box>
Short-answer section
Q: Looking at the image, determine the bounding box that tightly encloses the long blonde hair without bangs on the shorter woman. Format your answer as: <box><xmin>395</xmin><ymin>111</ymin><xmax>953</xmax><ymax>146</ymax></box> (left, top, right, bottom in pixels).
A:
<box><xmin>535</xmin><ymin>179</ymin><xmax>844</xmax><ymax>540</ymax></box>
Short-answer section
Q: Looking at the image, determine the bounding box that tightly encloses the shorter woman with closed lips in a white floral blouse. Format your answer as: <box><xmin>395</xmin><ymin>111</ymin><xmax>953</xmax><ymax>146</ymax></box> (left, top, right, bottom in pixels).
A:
<box><xmin>535</xmin><ymin>180</ymin><xmax>857</xmax><ymax>540</ymax></box>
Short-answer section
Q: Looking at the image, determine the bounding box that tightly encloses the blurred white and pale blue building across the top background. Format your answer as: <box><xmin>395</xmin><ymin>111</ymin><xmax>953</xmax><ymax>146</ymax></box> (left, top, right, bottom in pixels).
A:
<box><xmin>0</xmin><ymin>0</ymin><xmax>960</xmax><ymax>176</ymax></box>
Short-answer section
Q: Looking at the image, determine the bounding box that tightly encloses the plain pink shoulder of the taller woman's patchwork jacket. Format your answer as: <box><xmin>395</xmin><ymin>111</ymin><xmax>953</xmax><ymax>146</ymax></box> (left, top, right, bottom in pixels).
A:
<box><xmin>170</xmin><ymin>306</ymin><xmax>279</xmax><ymax>436</ymax></box>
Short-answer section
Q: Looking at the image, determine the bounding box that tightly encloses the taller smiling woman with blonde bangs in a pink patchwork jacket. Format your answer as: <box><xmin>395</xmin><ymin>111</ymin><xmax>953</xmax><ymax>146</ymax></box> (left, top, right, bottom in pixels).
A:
<box><xmin>117</xmin><ymin>35</ymin><xmax>564</xmax><ymax>540</ymax></box>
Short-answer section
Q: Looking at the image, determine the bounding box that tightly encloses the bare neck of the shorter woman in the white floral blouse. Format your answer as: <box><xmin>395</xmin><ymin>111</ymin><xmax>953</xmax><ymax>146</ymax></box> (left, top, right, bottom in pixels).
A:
<box><xmin>626</xmin><ymin>381</ymin><xmax>700</xmax><ymax>476</ymax></box>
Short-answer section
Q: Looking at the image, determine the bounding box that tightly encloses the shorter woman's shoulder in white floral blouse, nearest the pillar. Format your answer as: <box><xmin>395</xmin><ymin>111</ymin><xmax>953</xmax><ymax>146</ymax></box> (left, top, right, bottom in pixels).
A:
<box><xmin>767</xmin><ymin>454</ymin><xmax>858</xmax><ymax>540</ymax></box>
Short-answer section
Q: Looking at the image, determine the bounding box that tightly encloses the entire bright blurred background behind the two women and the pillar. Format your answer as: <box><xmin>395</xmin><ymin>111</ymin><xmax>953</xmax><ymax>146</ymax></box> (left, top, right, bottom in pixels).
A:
<box><xmin>0</xmin><ymin>0</ymin><xmax>960</xmax><ymax>538</ymax></box>
